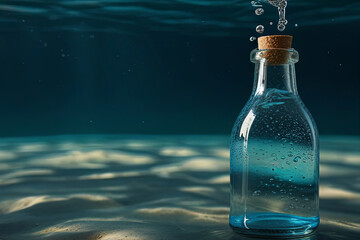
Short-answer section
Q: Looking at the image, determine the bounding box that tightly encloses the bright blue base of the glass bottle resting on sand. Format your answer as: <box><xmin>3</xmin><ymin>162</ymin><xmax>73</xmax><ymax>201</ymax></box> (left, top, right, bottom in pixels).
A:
<box><xmin>230</xmin><ymin>213</ymin><xmax>319</xmax><ymax>238</ymax></box>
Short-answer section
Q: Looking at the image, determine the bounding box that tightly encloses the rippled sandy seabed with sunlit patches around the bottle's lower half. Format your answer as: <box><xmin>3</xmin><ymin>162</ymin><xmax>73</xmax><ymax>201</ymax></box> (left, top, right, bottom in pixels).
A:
<box><xmin>0</xmin><ymin>135</ymin><xmax>360</xmax><ymax>240</ymax></box>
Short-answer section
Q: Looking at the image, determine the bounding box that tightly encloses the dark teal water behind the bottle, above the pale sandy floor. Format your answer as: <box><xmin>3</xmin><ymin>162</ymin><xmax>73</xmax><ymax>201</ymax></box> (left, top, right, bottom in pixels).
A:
<box><xmin>0</xmin><ymin>0</ymin><xmax>360</xmax><ymax>136</ymax></box>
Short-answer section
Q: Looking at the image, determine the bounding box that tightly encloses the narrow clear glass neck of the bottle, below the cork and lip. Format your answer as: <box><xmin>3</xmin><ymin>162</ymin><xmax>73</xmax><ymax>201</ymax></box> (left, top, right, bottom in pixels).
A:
<box><xmin>253</xmin><ymin>61</ymin><xmax>298</xmax><ymax>95</ymax></box>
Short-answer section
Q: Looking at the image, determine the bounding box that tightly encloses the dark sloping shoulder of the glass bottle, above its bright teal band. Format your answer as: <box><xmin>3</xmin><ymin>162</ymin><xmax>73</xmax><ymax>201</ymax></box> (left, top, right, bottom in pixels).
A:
<box><xmin>232</xmin><ymin>89</ymin><xmax>318</xmax><ymax>141</ymax></box>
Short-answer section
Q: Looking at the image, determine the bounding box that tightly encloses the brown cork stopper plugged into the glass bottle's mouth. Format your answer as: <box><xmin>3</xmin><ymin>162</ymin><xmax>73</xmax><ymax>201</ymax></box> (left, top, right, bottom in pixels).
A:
<box><xmin>258</xmin><ymin>35</ymin><xmax>293</xmax><ymax>65</ymax></box>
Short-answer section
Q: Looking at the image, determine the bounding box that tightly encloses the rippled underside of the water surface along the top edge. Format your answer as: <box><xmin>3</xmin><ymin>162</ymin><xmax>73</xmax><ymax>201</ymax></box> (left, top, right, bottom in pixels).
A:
<box><xmin>0</xmin><ymin>0</ymin><xmax>360</xmax><ymax>36</ymax></box>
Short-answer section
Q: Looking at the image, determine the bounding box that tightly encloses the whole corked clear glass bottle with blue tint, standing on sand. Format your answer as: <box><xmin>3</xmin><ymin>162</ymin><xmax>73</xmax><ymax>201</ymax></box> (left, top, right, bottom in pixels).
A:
<box><xmin>229</xmin><ymin>35</ymin><xmax>319</xmax><ymax>237</ymax></box>
